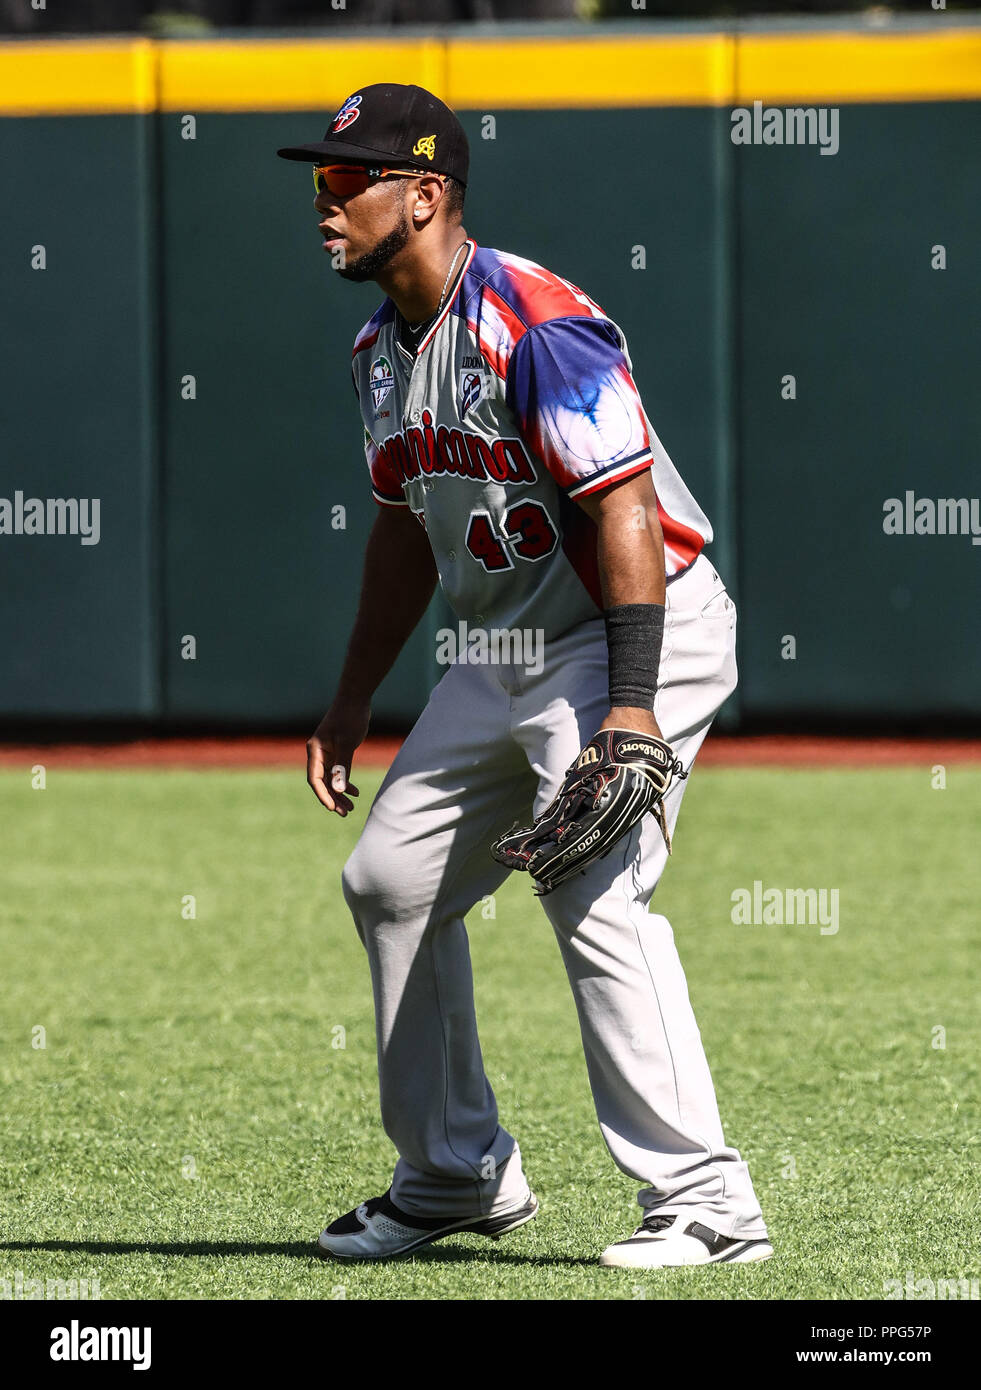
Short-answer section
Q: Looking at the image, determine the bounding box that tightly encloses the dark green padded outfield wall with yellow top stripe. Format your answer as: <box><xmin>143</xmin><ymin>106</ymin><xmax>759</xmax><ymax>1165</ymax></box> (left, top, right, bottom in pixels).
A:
<box><xmin>0</xmin><ymin>17</ymin><xmax>981</xmax><ymax>727</ymax></box>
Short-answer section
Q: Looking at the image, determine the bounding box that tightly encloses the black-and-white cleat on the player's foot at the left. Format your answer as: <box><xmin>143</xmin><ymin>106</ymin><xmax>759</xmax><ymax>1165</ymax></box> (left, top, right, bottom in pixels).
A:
<box><xmin>317</xmin><ymin>1188</ymin><xmax>538</xmax><ymax>1259</ymax></box>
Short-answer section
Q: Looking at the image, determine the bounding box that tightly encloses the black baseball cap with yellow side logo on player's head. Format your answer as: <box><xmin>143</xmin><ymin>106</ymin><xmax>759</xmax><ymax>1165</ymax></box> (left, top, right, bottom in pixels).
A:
<box><xmin>277</xmin><ymin>82</ymin><xmax>470</xmax><ymax>185</ymax></box>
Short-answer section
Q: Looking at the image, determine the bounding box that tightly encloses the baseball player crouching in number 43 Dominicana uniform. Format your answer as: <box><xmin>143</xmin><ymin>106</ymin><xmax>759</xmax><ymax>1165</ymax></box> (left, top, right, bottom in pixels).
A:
<box><xmin>278</xmin><ymin>83</ymin><xmax>773</xmax><ymax>1268</ymax></box>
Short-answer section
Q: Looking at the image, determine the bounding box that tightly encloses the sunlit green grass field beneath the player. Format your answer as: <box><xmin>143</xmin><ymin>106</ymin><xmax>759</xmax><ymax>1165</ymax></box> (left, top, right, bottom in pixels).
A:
<box><xmin>0</xmin><ymin>767</ymin><xmax>981</xmax><ymax>1300</ymax></box>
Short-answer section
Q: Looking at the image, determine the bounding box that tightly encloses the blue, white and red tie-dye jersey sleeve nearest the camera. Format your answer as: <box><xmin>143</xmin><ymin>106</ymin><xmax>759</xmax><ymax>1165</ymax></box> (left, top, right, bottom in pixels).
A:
<box><xmin>506</xmin><ymin>317</ymin><xmax>653</xmax><ymax>498</ymax></box>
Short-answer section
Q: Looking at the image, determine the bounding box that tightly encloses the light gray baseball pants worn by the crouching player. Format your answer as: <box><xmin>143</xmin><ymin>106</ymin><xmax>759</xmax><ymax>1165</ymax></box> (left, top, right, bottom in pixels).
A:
<box><xmin>343</xmin><ymin>556</ymin><xmax>766</xmax><ymax>1238</ymax></box>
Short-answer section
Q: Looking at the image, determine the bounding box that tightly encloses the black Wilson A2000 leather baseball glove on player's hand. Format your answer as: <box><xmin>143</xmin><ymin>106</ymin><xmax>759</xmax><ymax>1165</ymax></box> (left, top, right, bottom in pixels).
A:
<box><xmin>491</xmin><ymin>728</ymin><xmax>688</xmax><ymax>897</ymax></box>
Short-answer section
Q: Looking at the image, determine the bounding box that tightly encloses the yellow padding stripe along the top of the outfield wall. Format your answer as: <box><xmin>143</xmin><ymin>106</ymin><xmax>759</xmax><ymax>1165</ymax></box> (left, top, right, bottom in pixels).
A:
<box><xmin>0</xmin><ymin>28</ymin><xmax>981</xmax><ymax>115</ymax></box>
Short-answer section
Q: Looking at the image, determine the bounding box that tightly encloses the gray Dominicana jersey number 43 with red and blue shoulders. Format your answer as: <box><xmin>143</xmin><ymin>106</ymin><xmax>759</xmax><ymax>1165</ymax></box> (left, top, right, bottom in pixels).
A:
<box><xmin>352</xmin><ymin>239</ymin><xmax>711</xmax><ymax>641</ymax></box>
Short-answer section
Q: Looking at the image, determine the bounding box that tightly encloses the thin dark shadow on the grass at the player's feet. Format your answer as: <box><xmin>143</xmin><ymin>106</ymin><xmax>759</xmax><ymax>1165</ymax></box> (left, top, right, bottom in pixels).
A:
<box><xmin>0</xmin><ymin>1240</ymin><xmax>596</xmax><ymax>1269</ymax></box>
